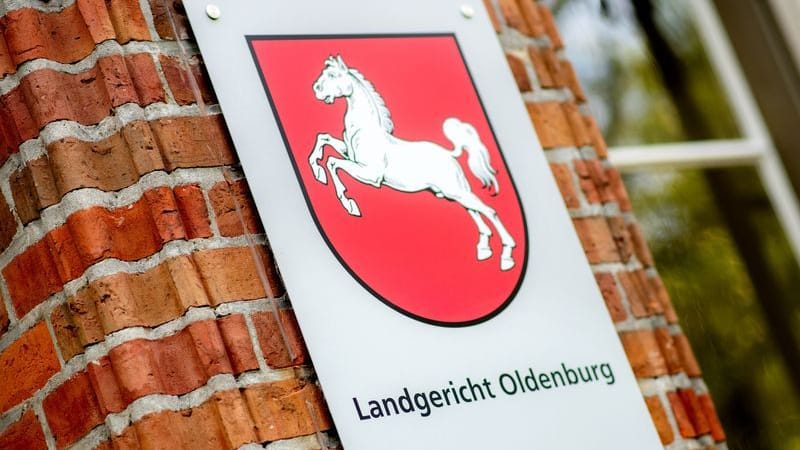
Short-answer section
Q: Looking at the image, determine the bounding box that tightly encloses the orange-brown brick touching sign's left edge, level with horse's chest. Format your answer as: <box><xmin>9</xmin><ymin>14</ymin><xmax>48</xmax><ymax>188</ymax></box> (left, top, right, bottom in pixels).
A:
<box><xmin>150</xmin><ymin>115</ymin><xmax>235</xmax><ymax>170</ymax></box>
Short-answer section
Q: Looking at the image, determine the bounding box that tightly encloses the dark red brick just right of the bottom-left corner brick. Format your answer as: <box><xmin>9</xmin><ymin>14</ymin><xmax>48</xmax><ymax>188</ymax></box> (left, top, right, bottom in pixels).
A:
<box><xmin>42</xmin><ymin>372</ymin><xmax>103</xmax><ymax>449</ymax></box>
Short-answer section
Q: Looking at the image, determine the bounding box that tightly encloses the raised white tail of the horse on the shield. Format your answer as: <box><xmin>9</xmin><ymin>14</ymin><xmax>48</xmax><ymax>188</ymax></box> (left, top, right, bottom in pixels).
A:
<box><xmin>442</xmin><ymin>117</ymin><xmax>500</xmax><ymax>195</ymax></box>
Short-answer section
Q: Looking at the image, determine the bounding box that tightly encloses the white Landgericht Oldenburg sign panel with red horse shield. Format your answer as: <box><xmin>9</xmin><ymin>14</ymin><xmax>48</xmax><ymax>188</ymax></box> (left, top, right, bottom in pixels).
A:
<box><xmin>184</xmin><ymin>0</ymin><xmax>661</xmax><ymax>450</ymax></box>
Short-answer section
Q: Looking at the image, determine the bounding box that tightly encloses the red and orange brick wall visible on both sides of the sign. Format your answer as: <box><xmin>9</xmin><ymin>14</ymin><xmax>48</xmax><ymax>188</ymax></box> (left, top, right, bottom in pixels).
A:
<box><xmin>0</xmin><ymin>0</ymin><xmax>724</xmax><ymax>449</ymax></box>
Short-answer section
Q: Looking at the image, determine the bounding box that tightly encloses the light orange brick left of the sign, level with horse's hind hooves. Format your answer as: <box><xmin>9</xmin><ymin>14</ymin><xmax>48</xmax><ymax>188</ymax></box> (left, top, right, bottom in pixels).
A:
<box><xmin>193</xmin><ymin>247</ymin><xmax>284</xmax><ymax>305</ymax></box>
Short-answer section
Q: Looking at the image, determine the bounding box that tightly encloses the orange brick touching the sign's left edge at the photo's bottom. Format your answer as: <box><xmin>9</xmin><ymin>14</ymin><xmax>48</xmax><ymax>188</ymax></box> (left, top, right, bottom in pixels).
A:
<box><xmin>244</xmin><ymin>380</ymin><xmax>331</xmax><ymax>441</ymax></box>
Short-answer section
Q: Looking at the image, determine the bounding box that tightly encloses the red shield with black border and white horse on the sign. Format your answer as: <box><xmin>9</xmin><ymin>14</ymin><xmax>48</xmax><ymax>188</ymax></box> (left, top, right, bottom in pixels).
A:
<box><xmin>248</xmin><ymin>35</ymin><xmax>528</xmax><ymax>326</ymax></box>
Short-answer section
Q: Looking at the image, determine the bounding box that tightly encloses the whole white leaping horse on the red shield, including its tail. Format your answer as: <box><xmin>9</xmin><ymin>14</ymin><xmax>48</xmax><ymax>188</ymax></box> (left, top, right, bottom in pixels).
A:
<box><xmin>308</xmin><ymin>56</ymin><xmax>516</xmax><ymax>270</ymax></box>
